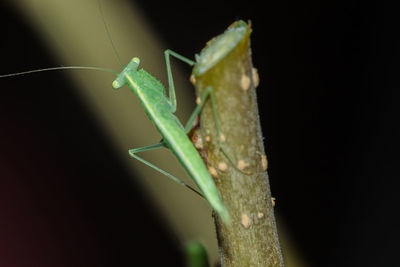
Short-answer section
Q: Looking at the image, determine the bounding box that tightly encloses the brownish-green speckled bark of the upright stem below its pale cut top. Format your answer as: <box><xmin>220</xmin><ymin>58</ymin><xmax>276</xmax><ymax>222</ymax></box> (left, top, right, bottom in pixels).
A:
<box><xmin>193</xmin><ymin>21</ymin><xmax>283</xmax><ymax>267</ymax></box>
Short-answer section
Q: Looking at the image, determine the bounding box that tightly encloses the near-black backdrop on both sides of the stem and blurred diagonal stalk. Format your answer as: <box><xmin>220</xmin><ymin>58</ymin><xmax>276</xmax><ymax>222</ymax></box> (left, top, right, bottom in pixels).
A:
<box><xmin>0</xmin><ymin>0</ymin><xmax>400</xmax><ymax>266</ymax></box>
